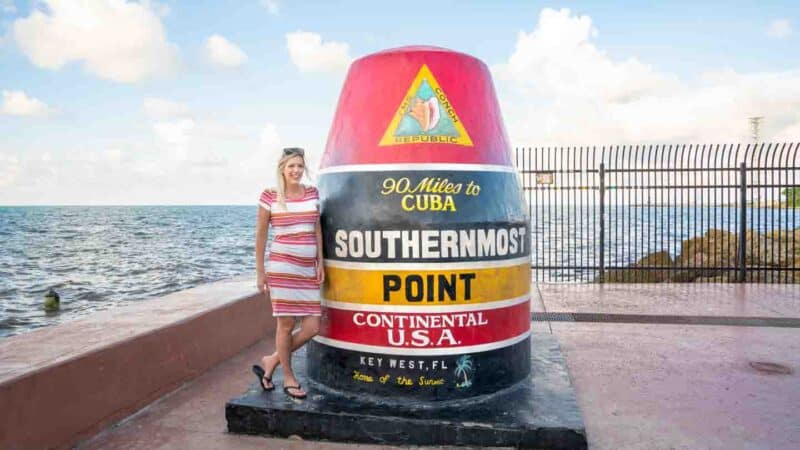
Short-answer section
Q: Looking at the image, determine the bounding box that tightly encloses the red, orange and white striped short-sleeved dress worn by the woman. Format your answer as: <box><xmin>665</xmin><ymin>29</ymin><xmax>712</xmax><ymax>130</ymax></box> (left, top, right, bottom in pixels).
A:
<box><xmin>258</xmin><ymin>187</ymin><xmax>321</xmax><ymax>316</ymax></box>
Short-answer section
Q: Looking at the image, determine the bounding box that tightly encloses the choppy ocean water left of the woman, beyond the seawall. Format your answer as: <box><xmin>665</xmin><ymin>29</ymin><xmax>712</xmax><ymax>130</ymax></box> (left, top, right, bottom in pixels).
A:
<box><xmin>0</xmin><ymin>206</ymin><xmax>257</xmax><ymax>338</ymax></box>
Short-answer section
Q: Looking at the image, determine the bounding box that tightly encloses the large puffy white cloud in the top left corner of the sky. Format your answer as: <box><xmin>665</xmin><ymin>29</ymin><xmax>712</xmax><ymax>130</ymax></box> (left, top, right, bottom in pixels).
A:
<box><xmin>12</xmin><ymin>0</ymin><xmax>177</xmax><ymax>83</ymax></box>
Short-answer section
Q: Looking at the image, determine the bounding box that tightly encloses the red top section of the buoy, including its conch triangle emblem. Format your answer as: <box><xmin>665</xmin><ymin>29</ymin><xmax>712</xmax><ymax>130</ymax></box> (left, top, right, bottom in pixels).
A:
<box><xmin>321</xmin><ymin>46</ymin><xmax>511</xmax><ymax>169</ymax></box>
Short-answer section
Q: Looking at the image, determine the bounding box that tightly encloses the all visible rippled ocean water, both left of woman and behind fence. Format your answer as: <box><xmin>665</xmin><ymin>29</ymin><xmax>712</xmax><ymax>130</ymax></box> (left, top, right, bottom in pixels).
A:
<box><xmin>0</xmin><ymin>205</ymin><xmax>800</xmax><ymax>338</ymax></box>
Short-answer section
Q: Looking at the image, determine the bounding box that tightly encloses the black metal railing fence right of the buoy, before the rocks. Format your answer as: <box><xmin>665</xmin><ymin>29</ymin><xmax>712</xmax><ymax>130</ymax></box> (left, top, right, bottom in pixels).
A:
<box><xmin>515</xmin><ymin>143</ymin><xmax>800</xmax><ymax>283</ymax></box>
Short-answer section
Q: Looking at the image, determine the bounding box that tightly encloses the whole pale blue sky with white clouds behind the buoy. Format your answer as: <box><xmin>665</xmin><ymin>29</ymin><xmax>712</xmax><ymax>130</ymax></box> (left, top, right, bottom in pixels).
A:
<box><xmin>0</xmin><ymin>0</ymin><xmax>800</xmax><ymax>205</ymax></box>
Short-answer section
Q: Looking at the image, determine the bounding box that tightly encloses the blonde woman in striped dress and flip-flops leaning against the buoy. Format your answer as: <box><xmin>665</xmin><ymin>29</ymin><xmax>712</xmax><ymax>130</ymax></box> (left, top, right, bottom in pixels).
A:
<box><xmin>253</xmin><ymin>148</ymin><xmax>325</xmax><ymax>399</ymax></box>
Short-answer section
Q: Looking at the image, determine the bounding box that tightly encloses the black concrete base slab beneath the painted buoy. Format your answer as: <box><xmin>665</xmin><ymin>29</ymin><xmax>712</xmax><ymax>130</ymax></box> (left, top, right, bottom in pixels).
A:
<box><xmin>225</xmin><ymin>334</ymin><xmax>587</xmax><ymax>449</ymax></box>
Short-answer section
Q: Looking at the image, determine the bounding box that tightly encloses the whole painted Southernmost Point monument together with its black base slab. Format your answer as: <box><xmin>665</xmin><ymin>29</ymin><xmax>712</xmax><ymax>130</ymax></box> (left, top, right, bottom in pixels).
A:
<box><xmin>226</xmin><ymin>47</ymin><xmax>586</xmax><ymax>448</ymax></box>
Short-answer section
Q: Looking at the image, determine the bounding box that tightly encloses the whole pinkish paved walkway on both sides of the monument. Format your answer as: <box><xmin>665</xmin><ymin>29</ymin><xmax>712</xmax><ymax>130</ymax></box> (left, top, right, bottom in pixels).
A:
<box><xmin>80</xmin><ymin>284</ymin><xmax>800</xmax><ymax>449</ymax></box>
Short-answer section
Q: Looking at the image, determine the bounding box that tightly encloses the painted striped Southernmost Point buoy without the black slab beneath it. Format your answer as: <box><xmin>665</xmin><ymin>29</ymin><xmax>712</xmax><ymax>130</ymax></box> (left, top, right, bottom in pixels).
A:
<box><xmin>308</xmin><ymin>47</ymin><xmax>531</xmax><ymax>400</ymax></box>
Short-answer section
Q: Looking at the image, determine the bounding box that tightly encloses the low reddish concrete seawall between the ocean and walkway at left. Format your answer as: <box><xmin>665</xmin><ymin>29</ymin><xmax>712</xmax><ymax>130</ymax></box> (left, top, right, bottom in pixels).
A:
<box><xmin>0</xmin><ymin>277</ymin><xmax>275</xmax><ymax>449</ymax></box>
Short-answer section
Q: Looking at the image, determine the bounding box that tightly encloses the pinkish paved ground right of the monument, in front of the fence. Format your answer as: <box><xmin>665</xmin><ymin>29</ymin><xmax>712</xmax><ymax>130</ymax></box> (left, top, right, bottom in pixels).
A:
<box><xmin>535</xmin><ymin>284</ymin><xmax>800</xmax><ymax>449</ymax></box>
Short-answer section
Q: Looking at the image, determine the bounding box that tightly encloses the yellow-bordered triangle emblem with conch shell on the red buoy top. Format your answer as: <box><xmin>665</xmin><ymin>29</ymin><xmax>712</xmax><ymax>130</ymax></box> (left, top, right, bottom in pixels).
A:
<box><xmin>378</xmin><ymin>64</ymin><xmax>472</xmax><ymax>147</ymax></box>
